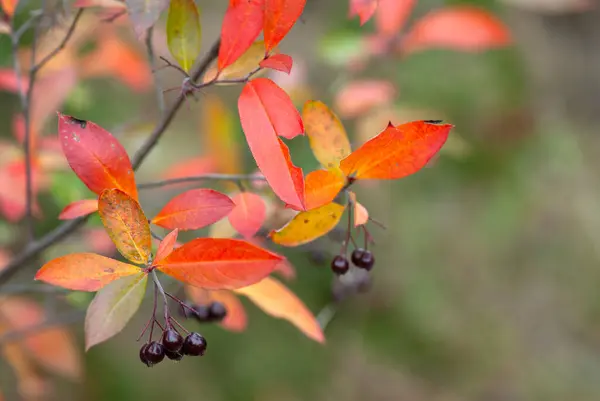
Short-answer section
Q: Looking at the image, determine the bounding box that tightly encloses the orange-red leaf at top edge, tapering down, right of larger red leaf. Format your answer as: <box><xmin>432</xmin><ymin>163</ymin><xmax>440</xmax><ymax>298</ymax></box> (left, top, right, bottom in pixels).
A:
<box><xmin>264</xmin><ymin>0</ymin><xmax>306</xmax><ymax>52</ymax></box>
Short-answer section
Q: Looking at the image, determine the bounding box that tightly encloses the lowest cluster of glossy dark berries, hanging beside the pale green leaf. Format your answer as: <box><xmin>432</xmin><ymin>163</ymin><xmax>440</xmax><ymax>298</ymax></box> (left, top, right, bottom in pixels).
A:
<box><xmin>140</xmin><ymin>328</ymin><xmax>207</xmax><ymax>367</ymax></box>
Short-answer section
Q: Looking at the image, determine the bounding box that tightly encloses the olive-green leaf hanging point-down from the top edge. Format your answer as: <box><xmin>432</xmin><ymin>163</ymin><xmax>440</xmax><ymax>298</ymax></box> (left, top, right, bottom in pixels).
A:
<box><xmin>167</xmin><ymin>0</ymin><xmax>202</xmax><ymax>72</ymax></box>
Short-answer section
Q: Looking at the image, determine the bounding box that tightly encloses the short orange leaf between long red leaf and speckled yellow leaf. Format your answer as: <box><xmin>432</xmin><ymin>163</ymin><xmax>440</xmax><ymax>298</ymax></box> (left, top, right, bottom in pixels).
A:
<box><xmin>304</xmin><ymin>170</ymin><xmax>346</xmax><ymax>210</ymax></box>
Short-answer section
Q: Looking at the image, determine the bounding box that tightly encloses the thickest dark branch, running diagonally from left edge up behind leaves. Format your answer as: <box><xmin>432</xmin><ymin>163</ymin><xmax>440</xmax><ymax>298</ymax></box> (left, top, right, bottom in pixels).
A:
<box><xmin>0</xmin><ymin>40</ymin><xmax>221</xmax><ymax>285</ymax></box>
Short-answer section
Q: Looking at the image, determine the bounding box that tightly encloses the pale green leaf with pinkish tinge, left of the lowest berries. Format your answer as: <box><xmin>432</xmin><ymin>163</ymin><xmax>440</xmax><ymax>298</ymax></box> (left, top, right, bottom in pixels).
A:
<box><xmin>85</xmin><ymin>273</ymin><xmax>148</xmax><ymax>351</ymax></box>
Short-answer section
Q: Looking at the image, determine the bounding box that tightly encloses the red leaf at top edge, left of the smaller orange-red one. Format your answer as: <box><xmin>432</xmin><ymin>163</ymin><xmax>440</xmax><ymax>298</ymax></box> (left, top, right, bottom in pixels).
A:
<box><xmin>217</xmin><ymin>0</ymin><xmax>264</xmax><ymax>70</ymax></box>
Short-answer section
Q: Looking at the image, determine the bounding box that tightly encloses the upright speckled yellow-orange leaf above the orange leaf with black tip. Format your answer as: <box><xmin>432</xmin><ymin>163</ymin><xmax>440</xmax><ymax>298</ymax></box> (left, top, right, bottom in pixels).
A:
<box><xmin>302</xmin><ymin>101</ymin><xmax>351</xmax><ymax>168</ymax></box>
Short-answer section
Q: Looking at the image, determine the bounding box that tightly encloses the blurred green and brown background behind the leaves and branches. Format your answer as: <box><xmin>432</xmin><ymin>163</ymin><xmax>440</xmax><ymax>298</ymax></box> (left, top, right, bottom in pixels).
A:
<box><xmin>0</xmin><ymin>0</ymin><xmax>600</xmax><ymax>401</ymax></box>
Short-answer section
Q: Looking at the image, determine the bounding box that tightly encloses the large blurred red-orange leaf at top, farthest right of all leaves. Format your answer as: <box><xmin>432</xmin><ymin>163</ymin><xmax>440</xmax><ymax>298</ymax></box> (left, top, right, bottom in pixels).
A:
<box><xmin>402</xmin><ymin>6</ymin><xmax>511</xmax><ymax>52</ymax></box>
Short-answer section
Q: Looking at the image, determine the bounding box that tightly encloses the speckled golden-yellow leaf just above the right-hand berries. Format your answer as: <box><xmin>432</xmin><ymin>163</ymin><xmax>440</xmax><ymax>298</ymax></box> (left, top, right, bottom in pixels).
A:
<box><xmin>269</xmin><ymin>203</ymin><xmax>345</xmax><ymax>246</ymax></box>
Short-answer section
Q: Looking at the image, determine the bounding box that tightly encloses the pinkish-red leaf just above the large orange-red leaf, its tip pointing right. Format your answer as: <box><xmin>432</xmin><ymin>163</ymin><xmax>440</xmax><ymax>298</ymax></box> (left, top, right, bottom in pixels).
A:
<box><xmin>152</xmin><ymin>188</ymin><xmax>235</xmax><ymax>230</ymax></box>
